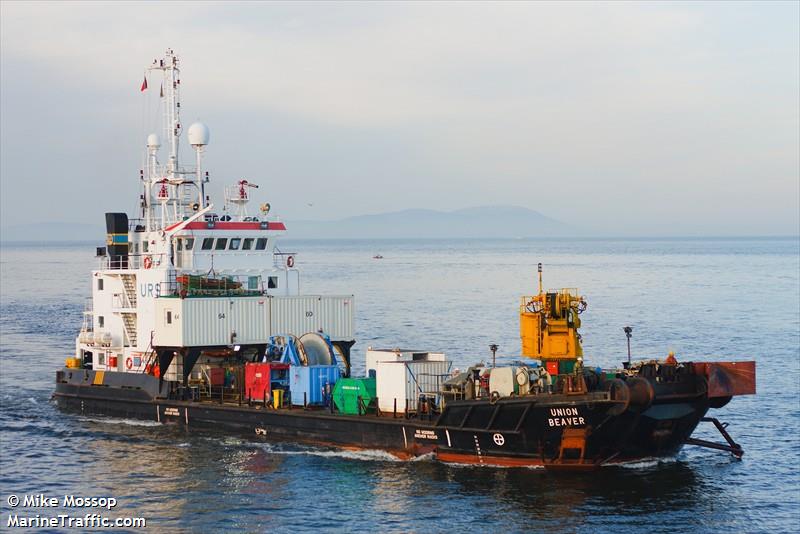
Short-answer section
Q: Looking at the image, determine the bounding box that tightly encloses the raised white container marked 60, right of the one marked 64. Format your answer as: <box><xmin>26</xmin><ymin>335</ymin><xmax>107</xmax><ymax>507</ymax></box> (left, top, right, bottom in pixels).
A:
<box><xmin>269</xmin><ymin>295</ymin><xmax>355</xmax><ymax>341</ymax></box>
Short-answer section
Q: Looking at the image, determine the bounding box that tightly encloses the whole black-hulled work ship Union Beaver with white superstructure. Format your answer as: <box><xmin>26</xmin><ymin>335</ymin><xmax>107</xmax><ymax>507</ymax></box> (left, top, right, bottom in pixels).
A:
<box><xmin>53</xmin><ymin>50</ymin><xmax>755</xmax><ymax>470</ymax></box>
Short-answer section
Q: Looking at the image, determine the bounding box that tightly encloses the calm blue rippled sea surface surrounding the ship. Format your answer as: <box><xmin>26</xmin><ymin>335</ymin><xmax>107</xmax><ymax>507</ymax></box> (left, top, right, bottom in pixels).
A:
<box><xmin>0</xmin><ymin>239</ymin><xmax>800</xmax><ymax>532</ymax></box>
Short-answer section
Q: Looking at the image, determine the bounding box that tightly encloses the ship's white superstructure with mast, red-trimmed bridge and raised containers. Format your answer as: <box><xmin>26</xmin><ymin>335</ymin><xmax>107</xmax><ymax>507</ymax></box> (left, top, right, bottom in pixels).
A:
<box><xmin>75</xmin><ymin>50</ymin><xmax>354</xmax><ymax>373</ymax></box>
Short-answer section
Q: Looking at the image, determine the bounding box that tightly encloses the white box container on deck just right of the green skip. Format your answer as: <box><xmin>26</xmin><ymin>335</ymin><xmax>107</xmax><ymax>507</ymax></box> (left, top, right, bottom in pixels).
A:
<box><xmin>375</xmin><ymin>360</ymin><xmax>451</xmax><ymax>413</ymax></box>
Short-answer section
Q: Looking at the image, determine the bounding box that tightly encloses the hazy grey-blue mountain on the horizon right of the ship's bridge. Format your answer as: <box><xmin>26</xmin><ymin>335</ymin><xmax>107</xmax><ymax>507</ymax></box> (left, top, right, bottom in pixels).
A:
<box><xmin>286</xmin><ymin>206</ymin><xmax>578</xmax><ymax>239</ymax></box>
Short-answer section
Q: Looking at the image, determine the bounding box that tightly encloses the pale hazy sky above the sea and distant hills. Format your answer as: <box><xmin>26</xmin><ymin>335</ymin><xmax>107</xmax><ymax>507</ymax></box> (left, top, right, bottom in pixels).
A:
<box><xmin>0</xmin><ymin>1</ymin><xmax>800</xmax><ymax>236</ymax></box>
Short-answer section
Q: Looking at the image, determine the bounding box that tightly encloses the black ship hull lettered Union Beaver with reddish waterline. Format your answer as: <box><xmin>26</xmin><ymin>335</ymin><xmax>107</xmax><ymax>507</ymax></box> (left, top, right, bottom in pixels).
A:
<box><xmin>54</xmin><ymin>370</ymin><xmax>709</xmax><ymax>469</ymax></box>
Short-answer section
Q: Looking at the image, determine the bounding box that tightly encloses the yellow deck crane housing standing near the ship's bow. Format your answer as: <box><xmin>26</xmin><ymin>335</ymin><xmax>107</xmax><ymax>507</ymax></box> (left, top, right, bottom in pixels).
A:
<box><xmin>519</xmin><ymin>263</ymin><xmax>586</xmax><ymax>374</ymax></box>
